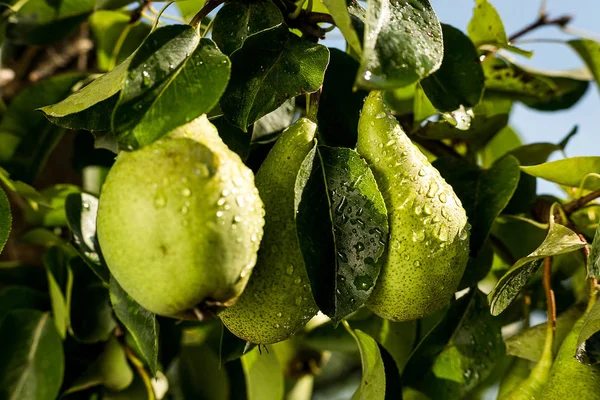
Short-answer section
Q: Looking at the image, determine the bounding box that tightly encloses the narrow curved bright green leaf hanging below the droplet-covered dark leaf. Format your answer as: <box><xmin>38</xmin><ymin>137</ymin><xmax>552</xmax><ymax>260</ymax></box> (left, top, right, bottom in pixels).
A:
<box><xmin>348</xmin><ymin>327</ymin><xmax>386</xmax><ymax>400</ymax></box>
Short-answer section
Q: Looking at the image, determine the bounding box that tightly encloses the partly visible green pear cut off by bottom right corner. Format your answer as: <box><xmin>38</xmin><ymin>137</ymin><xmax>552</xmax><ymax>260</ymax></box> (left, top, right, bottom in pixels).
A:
<box><xmin>536</xmin><ymin>313</ymin><xmax>600</xmax><ymax>400</ymax></box>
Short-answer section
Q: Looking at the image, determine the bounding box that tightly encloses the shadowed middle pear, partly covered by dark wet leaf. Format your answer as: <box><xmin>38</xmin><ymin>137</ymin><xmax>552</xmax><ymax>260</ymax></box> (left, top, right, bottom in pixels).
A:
<box><xmin>220</xmin><ymin>118</ymin><xmax>318</xmax><ymax>344</ymax></box>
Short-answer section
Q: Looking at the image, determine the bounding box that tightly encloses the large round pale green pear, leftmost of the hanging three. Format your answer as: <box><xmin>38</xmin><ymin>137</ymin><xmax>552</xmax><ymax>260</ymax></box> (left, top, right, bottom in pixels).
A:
<box><xmin>97</xmin><ymin>115</ymin><xmax>264</xmax><ymax>318</ymax></box>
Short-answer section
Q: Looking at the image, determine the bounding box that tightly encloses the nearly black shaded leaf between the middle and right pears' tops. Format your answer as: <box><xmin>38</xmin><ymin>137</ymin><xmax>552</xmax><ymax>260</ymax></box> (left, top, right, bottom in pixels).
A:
<box><xmin>317</xmin><ymin>48</ymin><xmax>367</xmax><ymax>148</ymax></box>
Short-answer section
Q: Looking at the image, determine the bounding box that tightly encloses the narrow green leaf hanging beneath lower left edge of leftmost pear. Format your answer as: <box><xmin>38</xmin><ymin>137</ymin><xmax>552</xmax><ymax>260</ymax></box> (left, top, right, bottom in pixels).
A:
<box><xmin>110</xmin><ymin>277</ymin><xmax>159</xmax><ymax>375</ymax></box>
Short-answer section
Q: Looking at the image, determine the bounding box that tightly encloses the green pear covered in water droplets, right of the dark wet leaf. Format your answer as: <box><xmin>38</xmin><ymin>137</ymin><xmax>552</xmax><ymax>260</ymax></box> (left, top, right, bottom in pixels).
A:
<box><xmin>357</xmin><ymin>92</ymin><xmax>470</xmax><ymax>321</ymax></box>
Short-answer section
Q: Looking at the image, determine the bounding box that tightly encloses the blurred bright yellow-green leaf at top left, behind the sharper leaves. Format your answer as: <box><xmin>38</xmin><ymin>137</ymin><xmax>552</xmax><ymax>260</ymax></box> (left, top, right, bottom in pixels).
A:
<box><xmin>89</xmin><ymin>9</ymin><xmax>152</xmax><ymax>71</ymax></box>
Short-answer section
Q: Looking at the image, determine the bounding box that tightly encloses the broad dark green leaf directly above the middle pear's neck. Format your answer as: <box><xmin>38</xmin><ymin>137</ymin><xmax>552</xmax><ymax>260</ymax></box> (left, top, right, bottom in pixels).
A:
<box><xmin>221</xmin><ymin>24</ymin><xmax>329</xmax><ymax>130</ymax></box>
